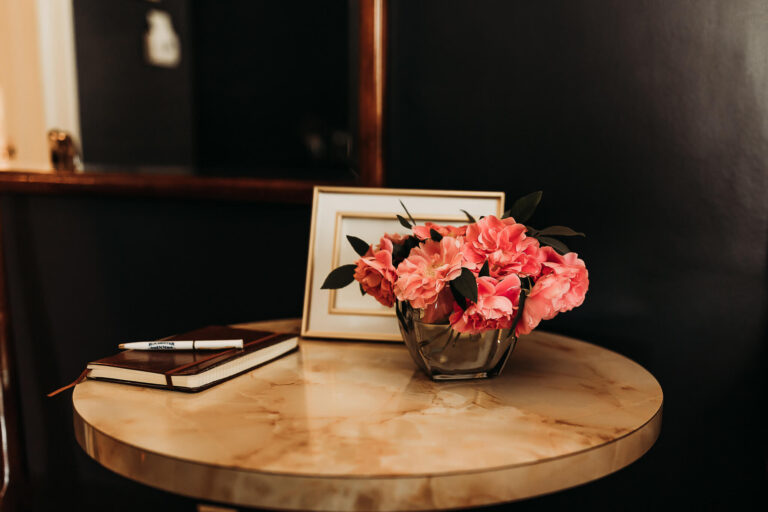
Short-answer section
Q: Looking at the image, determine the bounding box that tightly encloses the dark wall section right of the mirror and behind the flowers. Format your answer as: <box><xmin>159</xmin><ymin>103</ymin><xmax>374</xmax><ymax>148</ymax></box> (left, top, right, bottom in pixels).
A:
<box><xmin>387</xmin><ymin>0</ymin><xmax>768</xmax><ymax>508</ymax></box>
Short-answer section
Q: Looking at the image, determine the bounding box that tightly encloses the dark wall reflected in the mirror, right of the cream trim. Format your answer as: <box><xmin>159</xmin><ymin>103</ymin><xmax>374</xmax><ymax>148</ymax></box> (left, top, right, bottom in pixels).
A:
<box><xmin>73</xmin><ymin>0</ymin><xmax>357</xmax><ymax>179</ymax></box>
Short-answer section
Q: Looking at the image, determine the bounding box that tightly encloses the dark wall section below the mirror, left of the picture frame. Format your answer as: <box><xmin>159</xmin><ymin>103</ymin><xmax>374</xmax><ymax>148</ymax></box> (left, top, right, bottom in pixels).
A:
<box><xmin>0</xmin><ymin>197</ymin><xmax>310</xmax><ymax>511</ymax></box>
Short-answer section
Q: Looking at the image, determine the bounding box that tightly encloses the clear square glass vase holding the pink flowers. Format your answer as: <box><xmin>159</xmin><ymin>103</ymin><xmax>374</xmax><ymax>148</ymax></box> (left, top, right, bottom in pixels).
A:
<box><xmin>395</xmin><ymin>302</ymin><xmax>517</xmax><ymax>380</ymax></box>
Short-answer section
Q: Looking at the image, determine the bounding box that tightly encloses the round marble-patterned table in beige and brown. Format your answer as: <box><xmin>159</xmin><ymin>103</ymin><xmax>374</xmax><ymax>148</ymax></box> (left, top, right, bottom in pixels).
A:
<box><xmin>72</xmin><ymin>320</ymin><xmax>662</xmax><ymax>511</ymax></box>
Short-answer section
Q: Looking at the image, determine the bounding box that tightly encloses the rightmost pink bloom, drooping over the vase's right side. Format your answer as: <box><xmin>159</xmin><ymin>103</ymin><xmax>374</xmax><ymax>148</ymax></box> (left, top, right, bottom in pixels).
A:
<box><xmin>516</xmin><ymin>247</ymin><xmax>589</xmax><ymax>334</ymax></box>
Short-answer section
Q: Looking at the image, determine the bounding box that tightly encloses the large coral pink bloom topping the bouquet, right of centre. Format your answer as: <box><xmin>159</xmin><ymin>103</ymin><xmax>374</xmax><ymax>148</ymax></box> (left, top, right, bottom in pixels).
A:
<box><xmin>464</xmin><ymin>215</ymin><xmax>542</xmax><ymax>277</ymax></box>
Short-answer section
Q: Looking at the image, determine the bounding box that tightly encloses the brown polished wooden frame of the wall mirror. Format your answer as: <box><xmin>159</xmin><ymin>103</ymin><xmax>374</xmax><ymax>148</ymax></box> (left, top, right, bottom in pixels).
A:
<box><xmin>0</xmin><ymin>0</ymin><xmax>387</xmax><ymax>204</ymax></box>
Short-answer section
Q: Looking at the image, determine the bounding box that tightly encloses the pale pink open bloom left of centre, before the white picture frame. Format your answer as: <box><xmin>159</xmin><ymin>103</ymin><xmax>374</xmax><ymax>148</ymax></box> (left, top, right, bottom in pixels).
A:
<box><xmin>395</xmin><ymin>237</ymin><xmax>462</xmax><ymax>308</ymax></box>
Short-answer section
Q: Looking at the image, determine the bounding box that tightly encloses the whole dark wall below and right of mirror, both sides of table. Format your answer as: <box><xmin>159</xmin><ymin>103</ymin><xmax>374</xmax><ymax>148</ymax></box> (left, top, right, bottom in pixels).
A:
<box><xmin>2</xmin><ymin>0</ymin><xmax>768</xmax><ymax>510</ymax></box>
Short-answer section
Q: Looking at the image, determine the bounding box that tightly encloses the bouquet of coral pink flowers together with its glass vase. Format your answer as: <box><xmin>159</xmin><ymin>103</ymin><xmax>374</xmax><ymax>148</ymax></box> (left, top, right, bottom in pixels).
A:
<box><xmin>323</xmin><ymin>192</ymin><xmax>589</xmax><ymax>379</ymax></box>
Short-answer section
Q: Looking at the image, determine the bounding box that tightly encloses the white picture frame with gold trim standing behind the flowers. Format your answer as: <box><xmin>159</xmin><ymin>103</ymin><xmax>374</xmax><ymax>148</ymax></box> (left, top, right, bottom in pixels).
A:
<box><xmin>301</xmin><ymin>186</ymin><xmax>504</xmax><ymax>341</ymax></box>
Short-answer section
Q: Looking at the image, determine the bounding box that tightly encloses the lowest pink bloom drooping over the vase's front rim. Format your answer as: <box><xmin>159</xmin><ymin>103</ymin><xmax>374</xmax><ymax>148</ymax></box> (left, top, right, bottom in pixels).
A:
<box><xmin>449</xmin><ymin>274</ymin><xmax>520</xmax><ymax>334</ymax></box>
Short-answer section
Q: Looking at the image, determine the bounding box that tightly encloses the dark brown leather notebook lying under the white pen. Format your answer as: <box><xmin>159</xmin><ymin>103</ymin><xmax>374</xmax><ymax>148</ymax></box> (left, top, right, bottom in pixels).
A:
<box><xmin>86</xmin><ymin>326</ymin><xmax>298</xmax><ymax>392</ymax></box>
